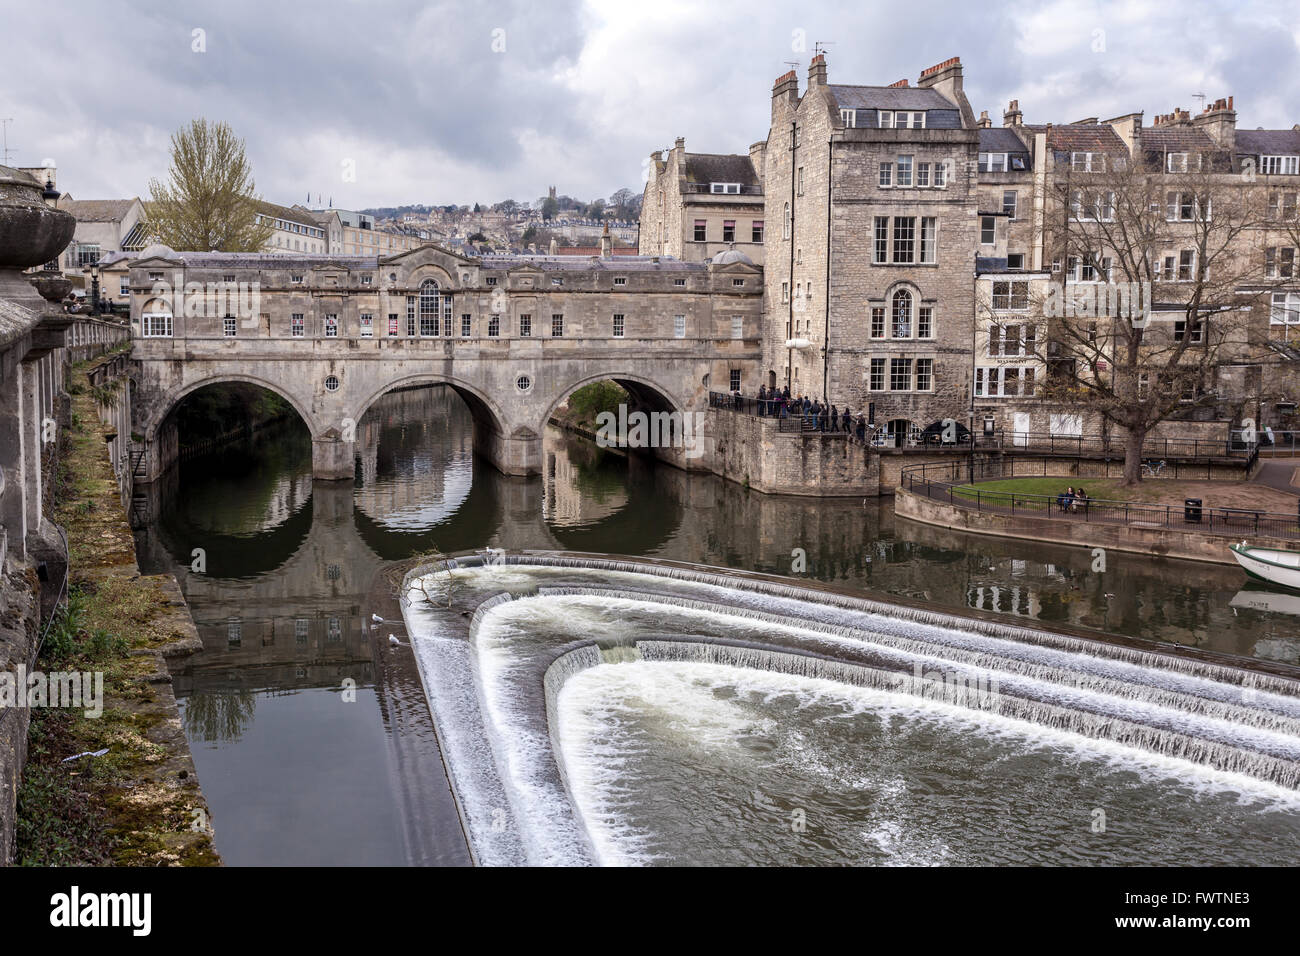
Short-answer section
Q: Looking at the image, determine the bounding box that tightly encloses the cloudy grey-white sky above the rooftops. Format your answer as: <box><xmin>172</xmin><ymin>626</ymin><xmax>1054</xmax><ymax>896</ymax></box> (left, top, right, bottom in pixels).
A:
<box><xmin>0</xmin><ymin>0</ymin><xmax>1300</xmax><ymax>208</ymax></box>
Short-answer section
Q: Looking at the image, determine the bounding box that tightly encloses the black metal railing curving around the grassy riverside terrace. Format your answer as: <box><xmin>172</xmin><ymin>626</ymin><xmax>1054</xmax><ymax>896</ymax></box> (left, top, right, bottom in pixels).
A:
<box><xmin>900</xmin><ymin>458</ymin><xmax>1300</xmax><ymax>540</ymax></box>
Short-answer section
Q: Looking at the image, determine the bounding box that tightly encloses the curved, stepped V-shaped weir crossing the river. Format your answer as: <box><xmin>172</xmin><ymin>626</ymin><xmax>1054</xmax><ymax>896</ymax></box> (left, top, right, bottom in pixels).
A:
<box><xmin>395</xmin><ymin>553</ymin><xmax>1300</xmax><ymax>864</ymax></box>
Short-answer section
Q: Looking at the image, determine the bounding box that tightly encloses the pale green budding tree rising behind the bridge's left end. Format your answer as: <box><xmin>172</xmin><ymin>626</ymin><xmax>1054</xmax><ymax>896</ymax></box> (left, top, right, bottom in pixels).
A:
<box><xmin>146</xmin><ymin>120</ymin><xmax>273</xmax><ymax>252</ymax></box>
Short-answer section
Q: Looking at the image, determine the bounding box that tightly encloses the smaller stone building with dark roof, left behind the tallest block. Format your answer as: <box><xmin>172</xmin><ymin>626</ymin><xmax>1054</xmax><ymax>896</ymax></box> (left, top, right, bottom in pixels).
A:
<box><xmin>638</xmin><ymin>137</ymin><xmax>766</xmax><ymax>265</ymax></box>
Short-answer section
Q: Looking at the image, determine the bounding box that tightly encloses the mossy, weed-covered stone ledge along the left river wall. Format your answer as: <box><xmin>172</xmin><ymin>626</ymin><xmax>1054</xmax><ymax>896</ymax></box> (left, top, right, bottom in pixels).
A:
<box><xmin>16</xmin><ymin>358</ymin><xmax>220</xmax><ymax>866</ymax></box>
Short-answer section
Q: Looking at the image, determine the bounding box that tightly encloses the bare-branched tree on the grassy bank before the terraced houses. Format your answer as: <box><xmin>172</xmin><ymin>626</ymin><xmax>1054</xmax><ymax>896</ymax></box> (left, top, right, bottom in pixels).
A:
<box><xmin>1041</xmin><ymin>146</ymin><xmax>1265</xmax><ymax>484</ymax></box>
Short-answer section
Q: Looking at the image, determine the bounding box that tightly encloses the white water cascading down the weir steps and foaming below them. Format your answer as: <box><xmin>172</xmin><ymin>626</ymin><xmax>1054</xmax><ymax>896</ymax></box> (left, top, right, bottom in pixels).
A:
<box><xmin>395</xmin><ymin>554</ymin><xmax>1300</xmax><ymax>864</ymax></box>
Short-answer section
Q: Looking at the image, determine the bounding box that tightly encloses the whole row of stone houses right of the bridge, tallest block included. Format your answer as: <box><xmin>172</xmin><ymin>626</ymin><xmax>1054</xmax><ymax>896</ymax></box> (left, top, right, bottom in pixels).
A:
<box><xmin>640</xmin><ymin>56</ymin><xmax>1300</xmax><ymax>444</ymax></box>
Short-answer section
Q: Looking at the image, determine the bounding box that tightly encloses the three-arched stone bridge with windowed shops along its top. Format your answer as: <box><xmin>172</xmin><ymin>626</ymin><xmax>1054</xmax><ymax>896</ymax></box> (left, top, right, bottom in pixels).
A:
<box><xmin>129</xmin><ymin>245</ymin><xmax>762</xmax><ymax>480</ymax></box>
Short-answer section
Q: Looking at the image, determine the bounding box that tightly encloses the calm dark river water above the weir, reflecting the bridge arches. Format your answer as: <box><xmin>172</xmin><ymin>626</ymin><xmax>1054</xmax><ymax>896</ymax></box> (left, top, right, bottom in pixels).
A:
<box><xmin>137</xmin><ymin>388</ymin><xmax>1300</xmax><ymax>865</ymax></box>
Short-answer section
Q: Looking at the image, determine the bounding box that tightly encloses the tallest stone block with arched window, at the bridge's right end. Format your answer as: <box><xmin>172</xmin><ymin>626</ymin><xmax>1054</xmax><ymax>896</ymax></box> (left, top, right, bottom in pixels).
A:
<box><xmin>763</xmin><ymin>56</ymin><xmax>980</xmax><ymax>442</ymax></box>
